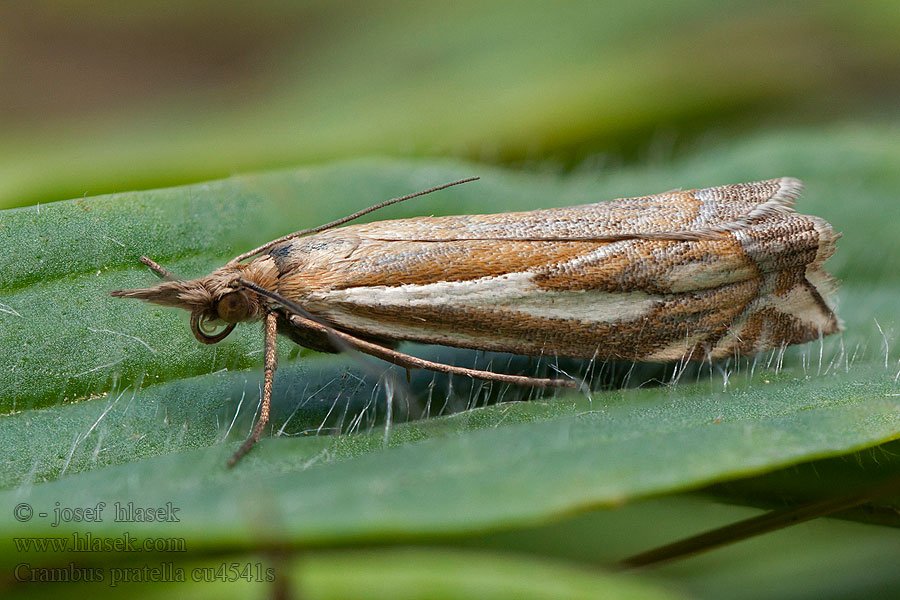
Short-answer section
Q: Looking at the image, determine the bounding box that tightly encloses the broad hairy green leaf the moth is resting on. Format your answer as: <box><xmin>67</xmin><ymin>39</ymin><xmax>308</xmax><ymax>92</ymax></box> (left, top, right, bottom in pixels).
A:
<box><xmin>0</xmin><ymin>127</ymin><xmax>900</xmax><ymax>596</ymax></box>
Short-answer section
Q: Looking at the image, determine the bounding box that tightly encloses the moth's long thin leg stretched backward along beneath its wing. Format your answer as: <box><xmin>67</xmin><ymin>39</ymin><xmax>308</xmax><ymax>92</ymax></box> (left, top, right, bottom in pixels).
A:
<box><xmin>290</xmin><ymin>315</ymin><xmax>579</xmax><ymax>387</ymax></box>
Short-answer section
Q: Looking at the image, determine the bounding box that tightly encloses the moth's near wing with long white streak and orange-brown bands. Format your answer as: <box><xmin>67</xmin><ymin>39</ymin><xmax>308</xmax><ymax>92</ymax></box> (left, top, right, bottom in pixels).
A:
<box><xmin>281</xmin><ymin>215</ymin><xmax>839</xmax><ymax>361</ymax></box>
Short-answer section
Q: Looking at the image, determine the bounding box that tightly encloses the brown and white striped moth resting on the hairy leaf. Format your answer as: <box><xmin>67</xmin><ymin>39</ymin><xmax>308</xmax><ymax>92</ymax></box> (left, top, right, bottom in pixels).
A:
<box><xmin>112</xmin><ymin>177</ymin><xmax>841</xmax><ymax>465</ymax></box>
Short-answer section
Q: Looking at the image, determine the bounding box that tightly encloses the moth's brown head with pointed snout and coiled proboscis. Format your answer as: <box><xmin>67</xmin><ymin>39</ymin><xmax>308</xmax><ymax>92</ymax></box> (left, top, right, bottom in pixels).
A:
<box><xmin>110</xmin><ymin>263</ymin><xmax>264</xmax><ymax>344</ymax></box>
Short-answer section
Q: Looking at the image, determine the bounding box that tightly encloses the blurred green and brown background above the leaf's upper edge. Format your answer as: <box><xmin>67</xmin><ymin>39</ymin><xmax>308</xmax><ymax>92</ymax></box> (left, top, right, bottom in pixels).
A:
<box><xmin>0</xmin><ymin>0</ymin><xmax>900</xmax><ymax>207</ymax></box>
